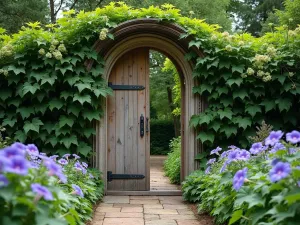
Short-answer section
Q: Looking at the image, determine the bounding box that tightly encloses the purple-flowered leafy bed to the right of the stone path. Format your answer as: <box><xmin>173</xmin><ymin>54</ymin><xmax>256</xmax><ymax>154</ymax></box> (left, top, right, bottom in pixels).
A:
<box><xmin>183</xmin><ymin>131</ymin><xmax>300</xmax><ymax>225</ymax></box>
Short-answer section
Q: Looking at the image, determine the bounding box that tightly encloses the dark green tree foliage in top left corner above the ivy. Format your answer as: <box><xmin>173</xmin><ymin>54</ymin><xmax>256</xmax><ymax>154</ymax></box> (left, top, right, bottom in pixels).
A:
<box><xmin>0</xmin><ymin>0</ymin><xmax>49</xmax><ymax>33</ymax></box>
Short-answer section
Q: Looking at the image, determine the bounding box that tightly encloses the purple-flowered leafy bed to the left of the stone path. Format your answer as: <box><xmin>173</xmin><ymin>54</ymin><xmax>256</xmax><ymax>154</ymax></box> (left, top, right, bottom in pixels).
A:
<box><xmin>0</xmin><ymin>143</ymin><xmax>103</xmax><ymax>225</ymax></box>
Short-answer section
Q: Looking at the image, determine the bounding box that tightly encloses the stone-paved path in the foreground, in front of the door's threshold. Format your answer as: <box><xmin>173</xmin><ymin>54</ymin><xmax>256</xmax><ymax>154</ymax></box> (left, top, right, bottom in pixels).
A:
<box><xmin>91</xmin><ymin>196</ymin><xmax>206</xmax><ymax>225</ymax></box>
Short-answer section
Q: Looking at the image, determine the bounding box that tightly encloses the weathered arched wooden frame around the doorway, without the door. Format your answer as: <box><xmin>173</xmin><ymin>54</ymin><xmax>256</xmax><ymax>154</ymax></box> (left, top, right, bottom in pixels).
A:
<box><xmin>87</xmin><ymin>19</ymin><xmax>206</xmax><ymax>195</ymax></box>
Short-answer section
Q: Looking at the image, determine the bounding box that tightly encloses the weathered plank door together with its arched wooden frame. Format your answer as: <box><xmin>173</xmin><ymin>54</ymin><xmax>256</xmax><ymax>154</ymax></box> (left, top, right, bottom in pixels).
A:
<box><xmin>88</xmin><ymin>19</ymin><xmax>205</xmax><ymax>194</ymax></box>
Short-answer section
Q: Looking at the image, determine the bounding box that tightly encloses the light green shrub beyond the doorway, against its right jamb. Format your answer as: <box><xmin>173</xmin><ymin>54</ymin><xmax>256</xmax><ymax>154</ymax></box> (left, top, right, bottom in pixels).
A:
<box><xmin>164</xmin><ymin>137</ymin><xmax>181</xmax><ymax>184</ymax></box>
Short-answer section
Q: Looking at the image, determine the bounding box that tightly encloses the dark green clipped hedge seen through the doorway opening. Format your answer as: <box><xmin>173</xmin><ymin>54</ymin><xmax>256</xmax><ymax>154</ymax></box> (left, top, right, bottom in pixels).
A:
<box><xmin>150</xmin><ymin>120</ymin><xmax>175</xmax><ymax>155</ymax></box>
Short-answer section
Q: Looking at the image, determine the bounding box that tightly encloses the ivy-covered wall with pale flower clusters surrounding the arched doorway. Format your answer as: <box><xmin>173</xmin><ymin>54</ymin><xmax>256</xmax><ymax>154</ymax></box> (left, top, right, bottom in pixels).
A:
<box><xmin>0</xmin><ymin>3</ymin><xmax>300</xmax><ymax>159</ymax></box>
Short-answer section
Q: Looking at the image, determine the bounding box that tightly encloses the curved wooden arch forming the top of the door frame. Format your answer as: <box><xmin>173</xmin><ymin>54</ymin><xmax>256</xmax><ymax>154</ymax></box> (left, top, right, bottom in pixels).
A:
<box><xmin>93</xmin><ymin>18</ymin><xmax>203</xmax><ymax>83</ymax></box>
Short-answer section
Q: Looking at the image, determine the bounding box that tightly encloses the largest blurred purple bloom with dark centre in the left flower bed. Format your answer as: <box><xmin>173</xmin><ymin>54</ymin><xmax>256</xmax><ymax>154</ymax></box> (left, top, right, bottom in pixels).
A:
<box><xmin>6</xmin><ymin>156</ymin><xmax>30</xmax><ymax>176</ymax></box>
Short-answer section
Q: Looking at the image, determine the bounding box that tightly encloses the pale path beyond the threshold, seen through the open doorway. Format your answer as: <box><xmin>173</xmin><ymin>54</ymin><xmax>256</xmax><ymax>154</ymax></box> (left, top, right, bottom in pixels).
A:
<box><xmin>150</xmin><ymin>155</ymin><xmax>180</xmax><ymax>191</ymax></box>
